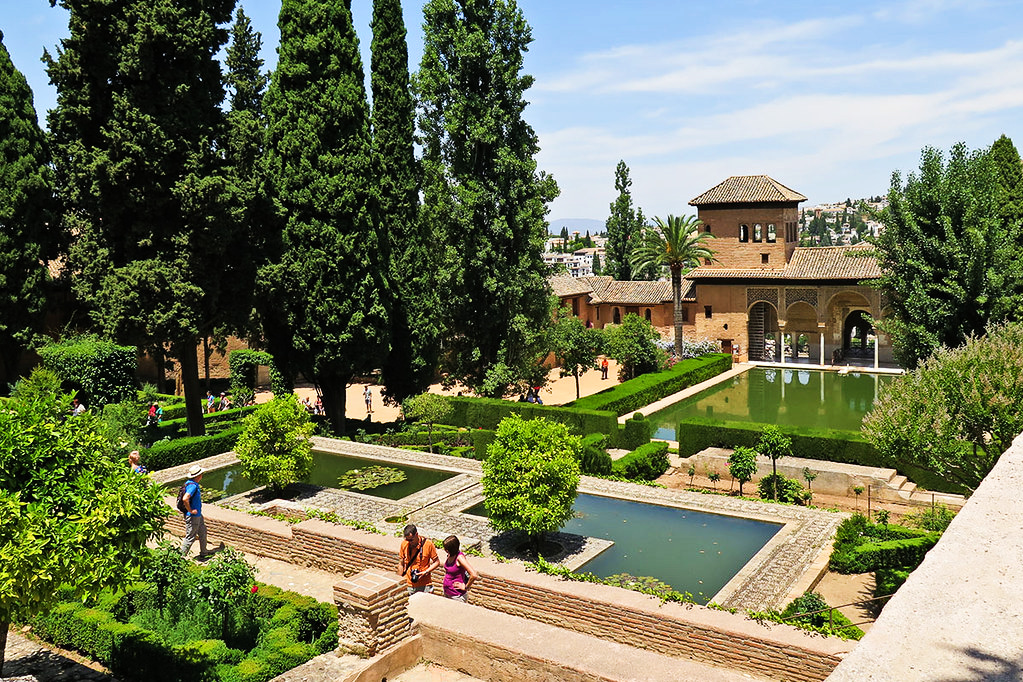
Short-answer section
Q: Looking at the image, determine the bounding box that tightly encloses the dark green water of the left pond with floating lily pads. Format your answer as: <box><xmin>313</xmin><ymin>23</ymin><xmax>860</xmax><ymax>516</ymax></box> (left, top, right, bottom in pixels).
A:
<box><xmin>168</xmin><ymin>451</ymin><xmax>455</xmax><ymax>500</ymax></box>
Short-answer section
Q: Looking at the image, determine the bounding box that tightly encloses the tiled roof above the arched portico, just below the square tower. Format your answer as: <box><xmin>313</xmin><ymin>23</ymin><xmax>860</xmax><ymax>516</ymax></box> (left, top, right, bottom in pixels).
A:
<box><xmin>685</xmin><ymin>243</ymin><xmax>881</xmax><ymax>279</ymax></box>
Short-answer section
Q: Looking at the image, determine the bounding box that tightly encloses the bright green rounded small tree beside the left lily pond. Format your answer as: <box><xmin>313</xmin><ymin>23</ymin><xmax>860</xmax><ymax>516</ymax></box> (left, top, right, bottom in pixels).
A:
<box><xmin>234</xmin><ymin>394</ymin><xmax>313</xmax><ymax>491</ymax></box>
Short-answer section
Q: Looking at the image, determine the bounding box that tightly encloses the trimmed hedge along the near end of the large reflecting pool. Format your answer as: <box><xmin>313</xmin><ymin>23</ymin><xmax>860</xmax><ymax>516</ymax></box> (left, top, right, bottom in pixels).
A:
<box><xmin>675</xmin><ymin>417</ymin><xmax>963</xmax><ymax>493</ymax></box>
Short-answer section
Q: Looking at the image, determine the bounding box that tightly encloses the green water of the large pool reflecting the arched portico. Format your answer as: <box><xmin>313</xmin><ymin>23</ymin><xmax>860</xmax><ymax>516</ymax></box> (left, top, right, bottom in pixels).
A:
<box><xmin>648</xmin><ymin>367</ymin><xmax>893</xmax><ymax>441</ymax></box>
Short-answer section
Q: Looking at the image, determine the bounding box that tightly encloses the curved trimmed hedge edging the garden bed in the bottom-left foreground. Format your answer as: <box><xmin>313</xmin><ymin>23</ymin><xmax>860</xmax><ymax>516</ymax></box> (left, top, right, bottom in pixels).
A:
<box><xmin>32</xmin><ymin>585</ymin><xmax>338</xmax><ymax>682</ymax></box>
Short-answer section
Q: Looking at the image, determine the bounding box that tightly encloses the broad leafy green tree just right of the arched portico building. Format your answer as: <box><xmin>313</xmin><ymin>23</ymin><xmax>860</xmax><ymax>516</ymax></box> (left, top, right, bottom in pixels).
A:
<box><xmin>875</xmin><ymin>143</ymin><xmax>1023</xmax><ymax>368</ymax></box>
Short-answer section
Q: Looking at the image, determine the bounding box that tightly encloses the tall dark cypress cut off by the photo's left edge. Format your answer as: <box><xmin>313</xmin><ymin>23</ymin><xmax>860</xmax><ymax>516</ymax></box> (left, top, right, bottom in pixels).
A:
<box><xmin>0</xmin><ymin>33</ymin><xmax>56</xmax><ymax>385</ymax></box>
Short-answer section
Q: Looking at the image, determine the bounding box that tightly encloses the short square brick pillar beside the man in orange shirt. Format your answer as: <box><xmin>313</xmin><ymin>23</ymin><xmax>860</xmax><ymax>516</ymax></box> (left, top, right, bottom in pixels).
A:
<box><xmin>333</xmin><ymin>569</ymin><xmax>412</xmax><ymax>656</ymax></box>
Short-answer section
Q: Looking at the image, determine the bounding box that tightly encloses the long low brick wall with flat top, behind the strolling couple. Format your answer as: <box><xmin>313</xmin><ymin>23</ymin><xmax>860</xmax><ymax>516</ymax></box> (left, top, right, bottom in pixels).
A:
<box><xmin>168</xmin><ymin>499</ymin><xmax>852</xmax><ymax>682</ymax></box>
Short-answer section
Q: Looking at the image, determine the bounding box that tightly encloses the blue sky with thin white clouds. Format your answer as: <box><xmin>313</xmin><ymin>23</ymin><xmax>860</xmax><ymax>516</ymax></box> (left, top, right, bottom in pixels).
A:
<box><xmin>0</xmin><ymin>0</ymin><xmax>1023</xmax><ymax>220</ymax></box>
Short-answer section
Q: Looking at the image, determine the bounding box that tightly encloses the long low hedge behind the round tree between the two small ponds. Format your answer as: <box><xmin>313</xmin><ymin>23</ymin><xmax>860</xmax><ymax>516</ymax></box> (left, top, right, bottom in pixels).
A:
<box><xmin>444</xmin><ymin>398</ymin><xmax>618</xmax><ymax>438</ymax></box>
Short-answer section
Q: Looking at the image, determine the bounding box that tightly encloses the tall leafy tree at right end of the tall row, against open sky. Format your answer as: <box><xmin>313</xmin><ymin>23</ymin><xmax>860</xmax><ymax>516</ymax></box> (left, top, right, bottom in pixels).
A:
<box><xmin>415</xmin><ymin>0</ymin><xmax>558</xmax><ymax>395</ymax></box>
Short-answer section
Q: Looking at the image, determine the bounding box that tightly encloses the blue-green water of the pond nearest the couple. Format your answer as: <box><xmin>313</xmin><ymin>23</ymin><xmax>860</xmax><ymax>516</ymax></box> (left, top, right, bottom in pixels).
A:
<box><xmin>465</xmin><ymin>495</ymin><xmax>782</xmax><ymax>601</ymax></box>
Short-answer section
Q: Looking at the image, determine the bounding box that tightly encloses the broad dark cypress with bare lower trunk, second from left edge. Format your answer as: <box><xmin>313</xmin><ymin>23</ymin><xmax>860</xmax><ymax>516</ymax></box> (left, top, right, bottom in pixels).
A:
<box><xmin>46</xmin><ymin>0</ymin><xmax>237</xmax><ymax>435</ymax></box>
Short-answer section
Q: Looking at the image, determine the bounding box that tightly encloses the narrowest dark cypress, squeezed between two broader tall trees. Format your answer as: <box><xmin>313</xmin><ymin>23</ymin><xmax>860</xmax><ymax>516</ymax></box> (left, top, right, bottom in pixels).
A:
<box><xmin>370</xmin><ymin>0</ymin><xmax>440</xmax><ymax>402</ymax></box>
